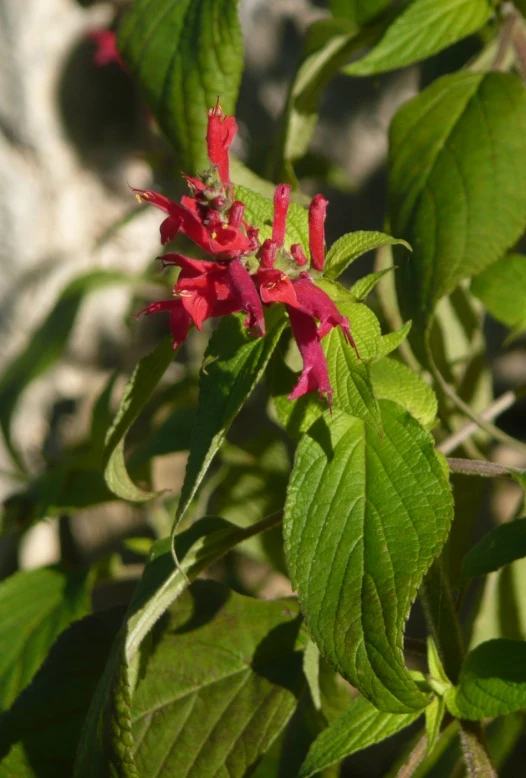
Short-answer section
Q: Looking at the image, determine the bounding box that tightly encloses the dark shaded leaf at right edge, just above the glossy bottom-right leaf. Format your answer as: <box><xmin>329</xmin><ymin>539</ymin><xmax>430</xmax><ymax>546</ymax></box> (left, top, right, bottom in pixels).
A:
<box><xmin>462</xmin><ymin>518</ymin><xmax>526</xmax><ymax>578</ymax></box>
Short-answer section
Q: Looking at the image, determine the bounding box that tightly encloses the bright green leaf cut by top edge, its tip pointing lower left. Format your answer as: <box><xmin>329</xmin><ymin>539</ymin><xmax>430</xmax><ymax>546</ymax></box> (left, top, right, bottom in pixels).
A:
<box><xmin>343</xmin><ymin>0</ymin><xmax>492</xmax><ymax>76</ymax></box>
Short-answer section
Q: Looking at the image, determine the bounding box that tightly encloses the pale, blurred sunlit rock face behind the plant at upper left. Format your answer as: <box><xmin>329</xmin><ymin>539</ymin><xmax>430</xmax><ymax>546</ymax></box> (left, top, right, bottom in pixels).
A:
<box><xmin>0</xmin><ymin>0</ymin><xmax>158</xmax><ymax>486</ymax></box>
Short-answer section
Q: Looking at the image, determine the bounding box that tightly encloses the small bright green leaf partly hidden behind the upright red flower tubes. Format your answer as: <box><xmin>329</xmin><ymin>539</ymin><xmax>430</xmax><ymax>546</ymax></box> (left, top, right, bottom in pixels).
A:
<box><xmin>234</xmin><ymin>186</ymin><xmax>309</xmax><ymax>247</ymax></box>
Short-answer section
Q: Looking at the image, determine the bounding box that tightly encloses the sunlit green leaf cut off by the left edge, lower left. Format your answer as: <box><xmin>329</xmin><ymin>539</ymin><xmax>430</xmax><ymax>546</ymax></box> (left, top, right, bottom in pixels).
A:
<box><xmin>0</xmin><ymin>567</ymin><xmax>89</xmax><ymax>711</ymax></box>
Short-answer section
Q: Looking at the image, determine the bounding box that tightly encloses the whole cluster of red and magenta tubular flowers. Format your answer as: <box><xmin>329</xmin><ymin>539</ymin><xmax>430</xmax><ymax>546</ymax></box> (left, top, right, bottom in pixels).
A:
<box><xmin>134</xmin><ymin>104</ymin><xmax>356</xmax><ymax>405</ymax></box>
